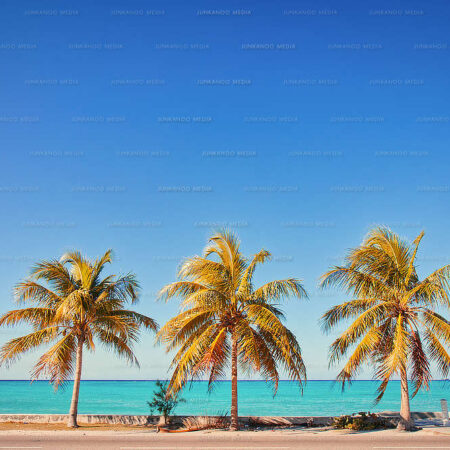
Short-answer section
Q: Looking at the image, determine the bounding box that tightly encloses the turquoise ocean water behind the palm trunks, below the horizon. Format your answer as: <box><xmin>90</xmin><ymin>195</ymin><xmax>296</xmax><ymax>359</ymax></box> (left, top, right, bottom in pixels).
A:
<box><xmin>0</xmin><ymin>380</ymin><xmax>450</xmax><ymax>416</ymax></box>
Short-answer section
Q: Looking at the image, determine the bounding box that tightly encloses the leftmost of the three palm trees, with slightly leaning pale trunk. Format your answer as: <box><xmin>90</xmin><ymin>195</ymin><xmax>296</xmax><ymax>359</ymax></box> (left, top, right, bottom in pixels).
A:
<box><xmin>0</xmin><ymin>250</ymin><xmax>158</xmax><ymax>427</ymax></box>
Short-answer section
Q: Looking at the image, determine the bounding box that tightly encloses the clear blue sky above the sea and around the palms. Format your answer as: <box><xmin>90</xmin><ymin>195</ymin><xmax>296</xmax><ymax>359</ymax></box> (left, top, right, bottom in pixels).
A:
<box><xmin>0</xmin><ymin>0</ymin><xmax>450</xmax><ymax>379</ymax></box>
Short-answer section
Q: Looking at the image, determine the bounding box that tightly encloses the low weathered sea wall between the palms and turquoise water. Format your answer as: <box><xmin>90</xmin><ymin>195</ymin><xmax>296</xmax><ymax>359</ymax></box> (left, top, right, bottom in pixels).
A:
<box><xmin>0</xmin><ymin>411</ymin><xmax>442</xmax><ymax>426</ymax></box>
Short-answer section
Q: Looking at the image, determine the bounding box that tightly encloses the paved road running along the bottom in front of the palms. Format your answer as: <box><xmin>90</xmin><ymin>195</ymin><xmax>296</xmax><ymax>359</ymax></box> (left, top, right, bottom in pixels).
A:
<box><xmin>0</xmin><ymin>432</ymin><xmax>450</xmax><ymax>450</ymax></box>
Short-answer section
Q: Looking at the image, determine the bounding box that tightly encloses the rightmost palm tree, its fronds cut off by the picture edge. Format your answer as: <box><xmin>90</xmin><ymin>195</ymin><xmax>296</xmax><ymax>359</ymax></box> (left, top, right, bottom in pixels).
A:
<box><xmin>321</xmin><ymin>227</ymin><xmax>450</xmax><ymax>430</ymax></box>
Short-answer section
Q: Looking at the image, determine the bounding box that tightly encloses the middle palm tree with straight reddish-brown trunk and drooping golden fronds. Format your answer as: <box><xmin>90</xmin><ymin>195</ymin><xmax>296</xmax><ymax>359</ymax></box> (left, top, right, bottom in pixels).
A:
<box><xmin>157</xmin><ymin>231</ymin><xmax>306</xmax><ymax>430</ymax></box>
